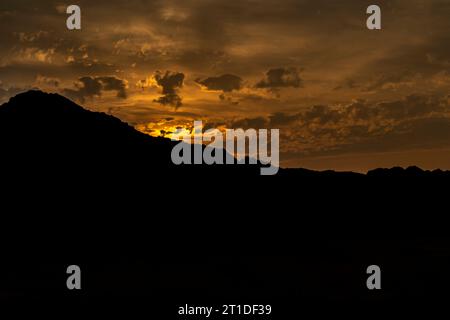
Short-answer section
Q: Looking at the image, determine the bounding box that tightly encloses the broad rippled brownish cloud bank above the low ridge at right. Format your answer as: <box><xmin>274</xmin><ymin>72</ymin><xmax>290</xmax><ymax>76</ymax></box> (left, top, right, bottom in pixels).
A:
<box><xmin>213</xmin><ymin>95</ymin><xmax>450</xmax><ymax>156</ymax></box>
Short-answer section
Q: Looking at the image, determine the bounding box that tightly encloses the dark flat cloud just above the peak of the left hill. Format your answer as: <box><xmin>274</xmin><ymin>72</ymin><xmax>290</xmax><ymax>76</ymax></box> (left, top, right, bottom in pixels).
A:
<box><xmin>62</xmin><ymin>76</ymin><xmax>127</xmax><ymax>103</ymax></box>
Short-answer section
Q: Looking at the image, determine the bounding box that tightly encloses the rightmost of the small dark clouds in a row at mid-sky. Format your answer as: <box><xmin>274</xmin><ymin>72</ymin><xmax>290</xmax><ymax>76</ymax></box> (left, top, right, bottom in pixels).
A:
<box><xmin>256</xmin><ymin>68</ymin><xmax>303</xmax><ymax>89</ymax></box>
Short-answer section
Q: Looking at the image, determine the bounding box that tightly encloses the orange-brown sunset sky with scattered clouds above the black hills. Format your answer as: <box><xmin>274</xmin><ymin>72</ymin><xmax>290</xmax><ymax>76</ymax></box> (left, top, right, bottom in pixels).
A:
<box><xmin>0</xmin><ymin>0</ymin><xmax>450</xmax><ymax>172</ymax></box>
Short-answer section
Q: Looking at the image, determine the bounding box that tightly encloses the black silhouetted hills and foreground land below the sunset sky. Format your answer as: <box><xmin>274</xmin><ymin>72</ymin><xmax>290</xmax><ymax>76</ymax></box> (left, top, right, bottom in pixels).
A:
<box><xmin>0</xmin><ymin>91</ymin><xmax>450</xmax><ymax>318</ymax></box>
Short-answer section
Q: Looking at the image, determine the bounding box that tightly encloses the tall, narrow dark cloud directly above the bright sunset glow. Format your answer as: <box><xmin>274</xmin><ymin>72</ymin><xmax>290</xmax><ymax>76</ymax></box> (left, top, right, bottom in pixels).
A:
<box><xmin>153</xmin><ymin>71</ymin><xmax>185</xmax><ymax>108</ymax></box>
